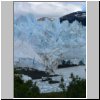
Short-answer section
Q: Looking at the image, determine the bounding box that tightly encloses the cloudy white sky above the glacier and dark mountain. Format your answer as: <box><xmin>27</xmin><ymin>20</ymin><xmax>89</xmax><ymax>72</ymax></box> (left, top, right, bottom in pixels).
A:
<box><xmin>14</xmin><ymin>2</ymin><xmax>86</xmax><ymax>17</ymax></box>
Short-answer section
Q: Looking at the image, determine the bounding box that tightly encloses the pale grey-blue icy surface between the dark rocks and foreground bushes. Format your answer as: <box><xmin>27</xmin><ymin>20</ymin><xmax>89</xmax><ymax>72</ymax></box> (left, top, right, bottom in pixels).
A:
<box><xmin>23</xmin><ymin>66</ymin><xmax>86</xmax><ymax>93</ymax></box>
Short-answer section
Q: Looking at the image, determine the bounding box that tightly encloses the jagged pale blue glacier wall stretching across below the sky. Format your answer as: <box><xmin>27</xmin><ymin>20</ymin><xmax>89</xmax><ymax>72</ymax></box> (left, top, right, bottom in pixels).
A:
<box><xmin>14</xmin><ymin>11</ymin><xmax>86</xmax><ymax>70</ymax></box>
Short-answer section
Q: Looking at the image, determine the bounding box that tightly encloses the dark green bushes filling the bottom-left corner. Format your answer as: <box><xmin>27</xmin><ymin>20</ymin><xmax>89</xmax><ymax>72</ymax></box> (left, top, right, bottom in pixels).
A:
<box><xmin>14</xmin><ymin>74</ymin><xmax>40</xmax><ymax>98</ymax></box>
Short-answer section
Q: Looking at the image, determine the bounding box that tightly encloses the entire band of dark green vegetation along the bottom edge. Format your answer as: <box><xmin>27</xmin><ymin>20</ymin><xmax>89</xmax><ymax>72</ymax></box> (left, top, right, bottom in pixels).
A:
<box><xmin>14</xmin><ymin>71</ymin><xmax>86</xmax><ymax>98</ymax></box>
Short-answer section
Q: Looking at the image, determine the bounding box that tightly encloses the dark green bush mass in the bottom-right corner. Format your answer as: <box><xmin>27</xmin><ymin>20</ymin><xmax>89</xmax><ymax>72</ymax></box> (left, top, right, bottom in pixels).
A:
<box><xmin>66</xmin><ymin>75</ymin><xmax>86</xmax><ymax>98</ymax></box>
